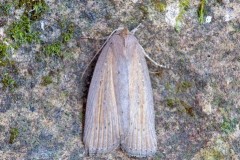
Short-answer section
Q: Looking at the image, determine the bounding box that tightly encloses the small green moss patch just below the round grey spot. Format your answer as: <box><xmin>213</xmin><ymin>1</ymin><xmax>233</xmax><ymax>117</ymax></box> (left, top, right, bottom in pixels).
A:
<box><xmin>43</xmin><ymin>42</ymin><xmax>62</xmax><ymax>57</ymax></box>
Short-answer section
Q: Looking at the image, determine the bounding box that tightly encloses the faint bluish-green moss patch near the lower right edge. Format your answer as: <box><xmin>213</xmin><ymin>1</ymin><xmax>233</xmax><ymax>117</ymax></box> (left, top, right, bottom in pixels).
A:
<box><xmin>221</xmin><ymin>117</ymin><xmax>238</xmax><ymax>134</ymax></box>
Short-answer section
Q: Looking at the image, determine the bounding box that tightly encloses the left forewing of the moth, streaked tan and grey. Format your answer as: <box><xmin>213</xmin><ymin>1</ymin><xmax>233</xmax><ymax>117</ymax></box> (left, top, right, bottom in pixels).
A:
<box><xmin>84</xmin><ymin>39</ymin><xmax>121</xmax><ymax>155</ymax></box>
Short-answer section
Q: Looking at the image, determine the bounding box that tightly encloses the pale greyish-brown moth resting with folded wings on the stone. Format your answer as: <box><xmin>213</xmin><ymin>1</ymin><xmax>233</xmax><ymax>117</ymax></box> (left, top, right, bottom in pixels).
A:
<box><xmin>83</xmin><ymin>28</ymin><xmax>157</xmax><ymax>157</ymax></box>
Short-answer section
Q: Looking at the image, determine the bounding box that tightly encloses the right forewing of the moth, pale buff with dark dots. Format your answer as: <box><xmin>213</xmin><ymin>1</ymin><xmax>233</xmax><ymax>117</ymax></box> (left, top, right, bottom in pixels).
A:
<box><xmin>121</xmin><ymin>35</ymin><xmax>157</xmax><ymax>157</ymax></box>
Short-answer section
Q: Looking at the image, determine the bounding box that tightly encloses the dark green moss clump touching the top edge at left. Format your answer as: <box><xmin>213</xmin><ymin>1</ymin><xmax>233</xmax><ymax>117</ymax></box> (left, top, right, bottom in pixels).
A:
<box><xmin>18</xmin><ymin>0</ymin><xmax>48</xmax><ymax>21</ymax></box>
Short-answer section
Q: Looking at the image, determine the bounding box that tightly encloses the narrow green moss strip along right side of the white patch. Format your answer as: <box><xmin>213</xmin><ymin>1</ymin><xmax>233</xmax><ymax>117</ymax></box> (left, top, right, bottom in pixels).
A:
<box><xmin>175</xmin><ymin>0</ymin><xmax>190</xmax><ymax>32</ymax></box>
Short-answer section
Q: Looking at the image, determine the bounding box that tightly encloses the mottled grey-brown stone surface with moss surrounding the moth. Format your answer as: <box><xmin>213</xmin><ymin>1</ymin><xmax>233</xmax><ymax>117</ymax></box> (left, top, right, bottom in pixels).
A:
<box><xmin>0</xmin><ymin>0</ymin><xmax>240</xmax><ymax>160</ymax></box>
